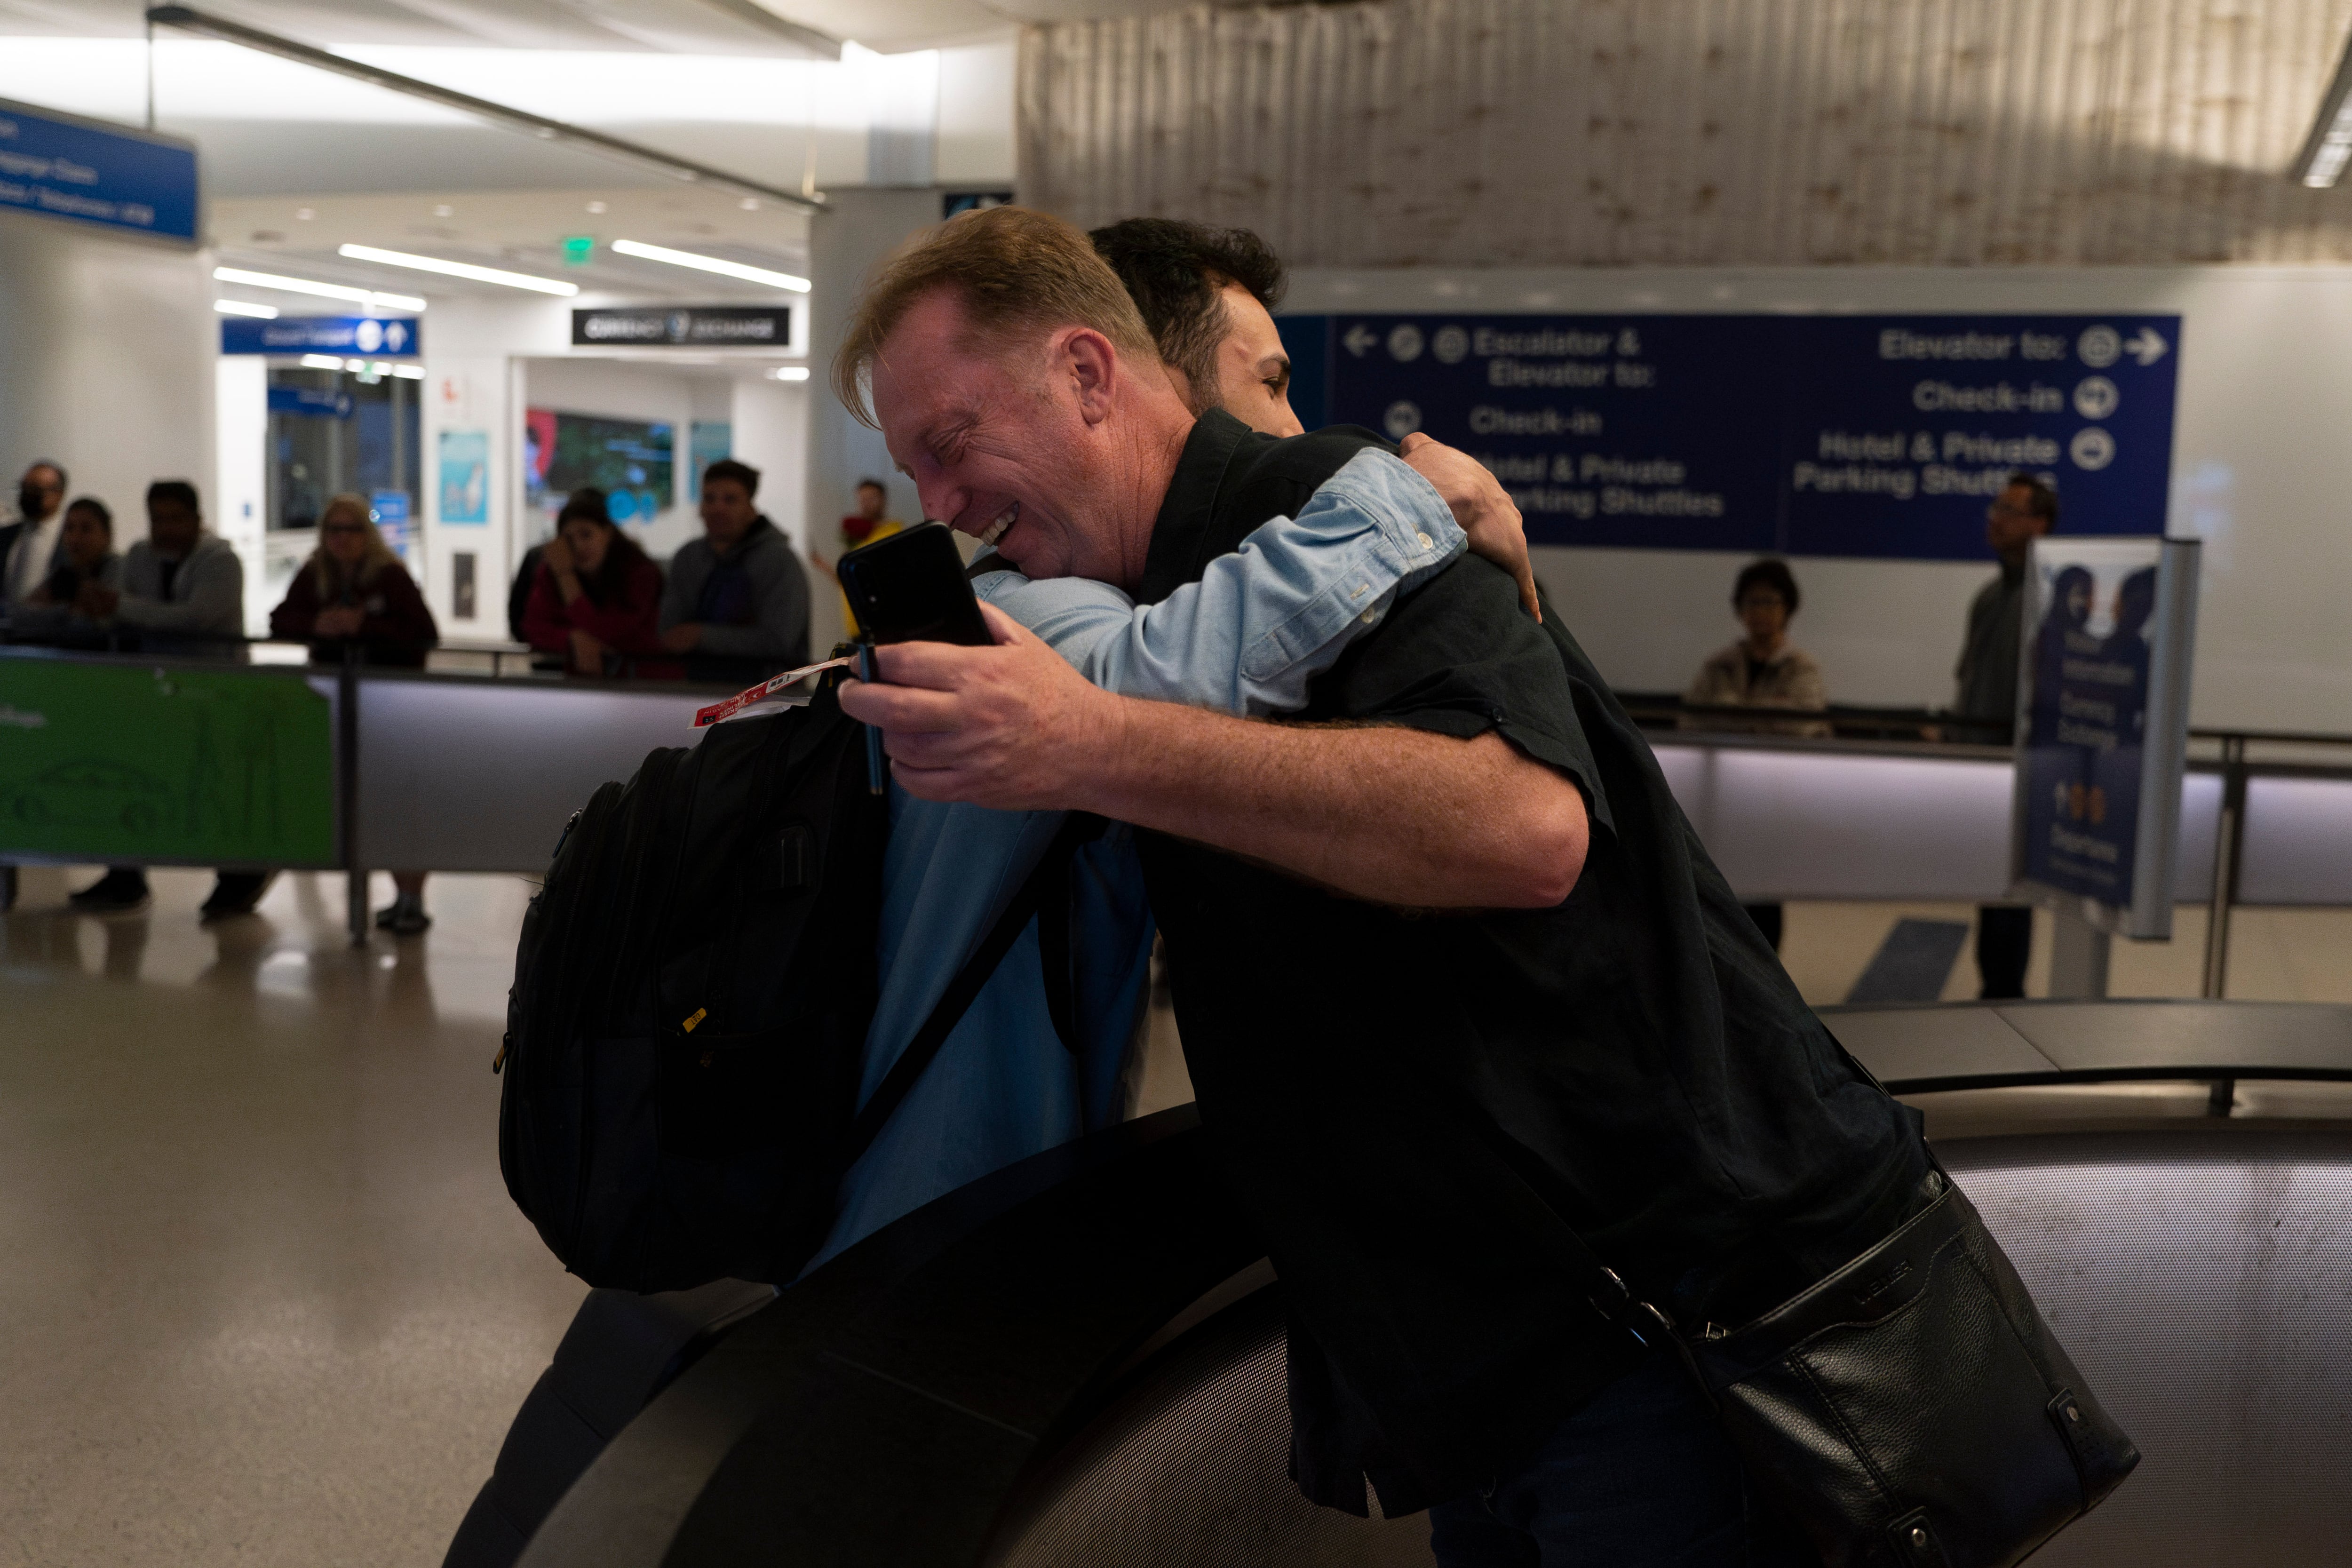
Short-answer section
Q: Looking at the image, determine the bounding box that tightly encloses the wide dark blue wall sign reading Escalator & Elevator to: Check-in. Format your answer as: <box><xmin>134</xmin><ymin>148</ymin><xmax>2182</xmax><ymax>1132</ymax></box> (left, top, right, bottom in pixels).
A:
<box><xmin>1279</xmin><ymin>315</ymin><xmax>2180</xmax><ymax>559</ymax></box>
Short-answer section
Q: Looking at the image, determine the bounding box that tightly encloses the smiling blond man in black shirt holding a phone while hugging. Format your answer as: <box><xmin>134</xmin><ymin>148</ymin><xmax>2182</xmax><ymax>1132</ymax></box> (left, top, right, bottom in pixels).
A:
<box><xmin>835</xmin><ymin>209</ymin><xmax>1926</xmax><ymax>1568</ymax></box>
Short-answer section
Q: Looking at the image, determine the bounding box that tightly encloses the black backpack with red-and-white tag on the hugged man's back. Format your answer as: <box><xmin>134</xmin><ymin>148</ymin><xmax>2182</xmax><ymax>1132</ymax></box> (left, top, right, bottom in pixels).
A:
<box><xmin>494</xmin><ymin>672</ymin><xmax>1101</xmax><ymax>1290</ymax></box>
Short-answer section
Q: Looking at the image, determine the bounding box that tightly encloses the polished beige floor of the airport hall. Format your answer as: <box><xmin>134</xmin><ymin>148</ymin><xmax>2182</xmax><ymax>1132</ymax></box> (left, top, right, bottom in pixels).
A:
<box><xmin>0</xmin><ymin>870</ymin><xmax>2352</xmax><ymax>1568</ymax></box>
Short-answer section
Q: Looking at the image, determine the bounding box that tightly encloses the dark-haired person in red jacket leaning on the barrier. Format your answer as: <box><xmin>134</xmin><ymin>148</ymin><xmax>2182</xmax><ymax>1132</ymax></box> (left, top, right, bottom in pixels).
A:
<box><xmin>522</xmin><ymin>489</ymin><xmax>684</xmax><ymax>679</ymax></box>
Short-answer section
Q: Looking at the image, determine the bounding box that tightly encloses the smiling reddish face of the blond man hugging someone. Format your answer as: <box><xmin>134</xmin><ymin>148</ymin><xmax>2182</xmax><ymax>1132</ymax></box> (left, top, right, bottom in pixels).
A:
<box><xmin>873</xmin><ymin>289</ymin><xmax>1122</xmax><ymax>583</ymax></box>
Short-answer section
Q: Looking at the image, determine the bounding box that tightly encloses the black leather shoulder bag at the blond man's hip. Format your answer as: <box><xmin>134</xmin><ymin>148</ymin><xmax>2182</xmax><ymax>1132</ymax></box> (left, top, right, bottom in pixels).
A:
<box><xmin>1595</xmin><ymin>1171</ymin><xmax>2140</xmax><ymax>1568</ymax></box>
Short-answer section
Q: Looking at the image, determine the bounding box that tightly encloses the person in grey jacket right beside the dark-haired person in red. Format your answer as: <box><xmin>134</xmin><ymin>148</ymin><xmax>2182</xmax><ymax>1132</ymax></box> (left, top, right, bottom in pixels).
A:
<box><xmin>661</xmin><ymin>458</ymin><xmax>809</xmax><ymax>686</ymax></box>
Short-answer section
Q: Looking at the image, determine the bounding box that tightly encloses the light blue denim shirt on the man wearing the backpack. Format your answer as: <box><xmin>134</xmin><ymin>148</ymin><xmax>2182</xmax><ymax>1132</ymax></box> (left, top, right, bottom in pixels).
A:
<box><xmin>809</xmin><ymin>451</ymin><xmax>1468</xmax><ymax>1269</ymax></box>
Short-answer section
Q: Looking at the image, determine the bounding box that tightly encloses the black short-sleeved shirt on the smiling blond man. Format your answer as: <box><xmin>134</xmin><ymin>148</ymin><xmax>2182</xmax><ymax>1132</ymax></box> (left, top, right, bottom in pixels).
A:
<box><xmin>1138</xmin><ymin>411</ymin><xmax>1924</xmax><ymax>1514</ymax></box>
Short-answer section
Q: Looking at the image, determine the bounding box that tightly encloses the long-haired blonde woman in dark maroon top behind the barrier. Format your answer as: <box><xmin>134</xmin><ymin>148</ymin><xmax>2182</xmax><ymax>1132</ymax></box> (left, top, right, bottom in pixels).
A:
<box><xmin>270</xmin><ymin>493</ymin><xmax>440</xmax><ymax>936</ymax></box>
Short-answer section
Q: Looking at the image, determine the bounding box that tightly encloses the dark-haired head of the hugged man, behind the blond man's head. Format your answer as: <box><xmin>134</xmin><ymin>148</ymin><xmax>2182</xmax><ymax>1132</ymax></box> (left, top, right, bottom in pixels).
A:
<box><xmin>1087</xmin><ymin>219</ymin><xmax>1305</xmax><ymax>435</ymax></box>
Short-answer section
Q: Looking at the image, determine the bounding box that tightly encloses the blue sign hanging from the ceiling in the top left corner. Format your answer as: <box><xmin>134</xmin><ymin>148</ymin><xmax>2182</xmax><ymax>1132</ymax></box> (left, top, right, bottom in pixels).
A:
<box><xmin>0</xmin><ymin>99</ymin><xmax>195</xmax><ymax>245</ymax></box>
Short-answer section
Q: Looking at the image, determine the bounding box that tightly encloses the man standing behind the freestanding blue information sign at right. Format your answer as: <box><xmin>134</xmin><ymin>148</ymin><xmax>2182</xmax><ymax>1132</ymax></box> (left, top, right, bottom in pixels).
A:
<box><xmin>1952</xmin><ymin>472</ymin><xmax>2058</xmax><ymax>1002</ymax></box>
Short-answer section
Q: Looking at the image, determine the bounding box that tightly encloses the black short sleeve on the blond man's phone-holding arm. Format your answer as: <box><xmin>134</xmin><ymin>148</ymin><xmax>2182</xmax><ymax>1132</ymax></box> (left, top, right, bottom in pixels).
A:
<box><xmin>1305</xmin><ymin>555</ymin><xmax>1609</xmax><ymax>841</ymax></box>
